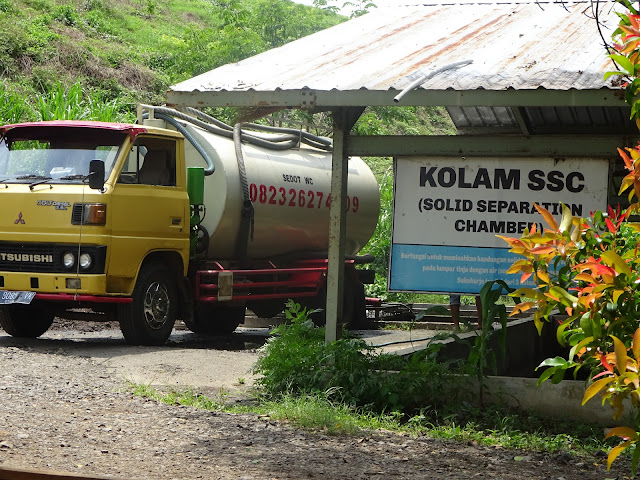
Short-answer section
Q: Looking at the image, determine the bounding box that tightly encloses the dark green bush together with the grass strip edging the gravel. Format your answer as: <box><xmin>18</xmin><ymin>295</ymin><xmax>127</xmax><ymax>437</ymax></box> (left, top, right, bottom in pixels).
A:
<box><xmin>130</xmin><ymin>304</ymin><xmax>608</xmax><ymax>456</ymax></box>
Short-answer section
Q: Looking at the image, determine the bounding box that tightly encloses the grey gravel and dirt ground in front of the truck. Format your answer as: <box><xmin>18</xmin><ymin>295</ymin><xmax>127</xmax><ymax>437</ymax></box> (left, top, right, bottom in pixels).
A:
<box><xmin>0</xmin><ymin>318</ymin><xmax>629</xmax><ymax>480</ymax></box>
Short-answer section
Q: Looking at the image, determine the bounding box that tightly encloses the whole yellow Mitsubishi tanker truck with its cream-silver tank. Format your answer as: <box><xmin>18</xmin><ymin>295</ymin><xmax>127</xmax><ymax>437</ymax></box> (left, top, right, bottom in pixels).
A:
<box><xmin>0</xmin><ymin>106</ymin><xmax>380</xmax><ymax>345</ymax></box>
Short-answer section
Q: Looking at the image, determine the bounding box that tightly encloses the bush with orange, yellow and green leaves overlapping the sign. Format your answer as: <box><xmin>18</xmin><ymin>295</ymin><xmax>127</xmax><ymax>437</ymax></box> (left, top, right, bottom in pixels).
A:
<box><xmin>502</xmin><ymin>199</ymin><xmax>640</xmax><ymax>470</ymax></box>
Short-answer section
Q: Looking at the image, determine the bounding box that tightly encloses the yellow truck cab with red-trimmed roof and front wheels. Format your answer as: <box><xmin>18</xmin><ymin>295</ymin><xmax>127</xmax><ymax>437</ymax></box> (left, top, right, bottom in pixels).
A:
<box><xmin>0</xmin><ymin>121</ymin><xmax>190</xmax><ymax>343</ymax></box>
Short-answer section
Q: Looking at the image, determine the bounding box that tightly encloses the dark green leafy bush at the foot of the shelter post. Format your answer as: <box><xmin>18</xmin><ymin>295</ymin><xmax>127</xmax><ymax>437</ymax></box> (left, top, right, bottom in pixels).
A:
<box><xmin>254</xmin><ymin>302</ymin><xmax>464</xmax><ymax>413</ymax></box>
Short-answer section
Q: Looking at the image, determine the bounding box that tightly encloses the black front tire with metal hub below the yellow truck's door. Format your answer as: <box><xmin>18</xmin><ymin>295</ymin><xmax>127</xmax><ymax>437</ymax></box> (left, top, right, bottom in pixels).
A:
<box><xmin>118</xmin><ymin>263</ymin><xmax>178</xmax><ymax>345</ymax></box>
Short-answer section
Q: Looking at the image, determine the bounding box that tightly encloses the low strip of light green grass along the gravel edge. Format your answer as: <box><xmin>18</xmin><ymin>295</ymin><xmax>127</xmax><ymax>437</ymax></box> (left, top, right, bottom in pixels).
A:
<box><xmin>129</xmin><ymin>383</ymin><xmax>611</xmax><ymax>457</ymax></box>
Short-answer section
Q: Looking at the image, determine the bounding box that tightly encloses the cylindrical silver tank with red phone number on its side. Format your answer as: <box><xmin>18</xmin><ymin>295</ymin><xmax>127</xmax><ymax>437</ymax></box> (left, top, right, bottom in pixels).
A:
<box><xmin>170</xmin><ymin>122</ymin><xmax>380</xmax><ymax>260</ymax></box>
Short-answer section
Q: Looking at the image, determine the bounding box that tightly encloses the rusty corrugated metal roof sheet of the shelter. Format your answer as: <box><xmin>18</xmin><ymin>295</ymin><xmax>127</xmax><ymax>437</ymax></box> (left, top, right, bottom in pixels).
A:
<box><xmin>171</xmin><ymin>2</ymin><xmax>618</xmax><ymax>92</ymax></box>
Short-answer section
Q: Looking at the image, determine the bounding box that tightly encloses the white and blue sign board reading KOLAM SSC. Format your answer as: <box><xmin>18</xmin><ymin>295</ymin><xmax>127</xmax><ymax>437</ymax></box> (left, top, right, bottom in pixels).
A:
<box><xmin>388</xmin><ymin>157</ymin><xmax>609</xmax><ymax>294</ymax></box>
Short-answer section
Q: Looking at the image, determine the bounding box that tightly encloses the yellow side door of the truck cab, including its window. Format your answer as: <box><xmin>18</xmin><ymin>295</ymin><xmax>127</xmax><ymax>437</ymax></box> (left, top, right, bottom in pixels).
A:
<box><xmin>108</xmin><ymin>136</ymin><xmax>189</xmax><ymax>286</ymax></box>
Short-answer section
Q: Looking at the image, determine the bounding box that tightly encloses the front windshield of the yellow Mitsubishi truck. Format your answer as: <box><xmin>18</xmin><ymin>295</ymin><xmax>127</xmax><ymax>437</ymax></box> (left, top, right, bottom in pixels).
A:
<box><xmin>0</xmin><ymin>126</ymin><xmax>127</xmax><ymax>184</ymax></box>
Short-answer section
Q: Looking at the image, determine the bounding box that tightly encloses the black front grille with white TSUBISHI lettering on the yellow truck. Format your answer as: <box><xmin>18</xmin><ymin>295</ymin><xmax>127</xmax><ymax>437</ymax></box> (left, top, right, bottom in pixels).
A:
<box><xmin>0</xmin><ymin>242</ymin><xmax>107</xmax><ymax>273</ymax></box>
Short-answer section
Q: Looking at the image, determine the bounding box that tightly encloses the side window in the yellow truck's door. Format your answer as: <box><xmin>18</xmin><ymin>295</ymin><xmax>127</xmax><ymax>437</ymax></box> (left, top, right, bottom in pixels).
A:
<box><xmin>118</xmin><ymin>137</ymin><xmax>176</xmax><ymax>187</ymax></box>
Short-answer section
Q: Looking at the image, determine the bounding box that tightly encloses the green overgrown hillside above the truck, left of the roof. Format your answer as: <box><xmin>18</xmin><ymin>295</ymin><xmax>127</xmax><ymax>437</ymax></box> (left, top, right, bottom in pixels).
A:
<box><xmin>0</xmin><ymin>0</ymin><xmax>346</xmax><ymax>122</ymax></box>
